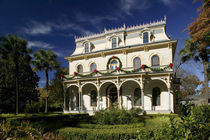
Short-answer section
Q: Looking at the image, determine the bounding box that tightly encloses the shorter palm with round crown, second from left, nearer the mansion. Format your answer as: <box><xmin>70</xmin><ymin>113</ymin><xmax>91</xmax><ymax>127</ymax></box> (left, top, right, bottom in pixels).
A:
<box><xmin>33</xmin><ymin>50</ymin><xmax>60</xmax><ymax>112</ymax></box>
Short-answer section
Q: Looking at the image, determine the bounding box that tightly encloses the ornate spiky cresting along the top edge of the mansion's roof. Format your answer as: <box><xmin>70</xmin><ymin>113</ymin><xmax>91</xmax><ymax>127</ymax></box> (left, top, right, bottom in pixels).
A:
<box><xmin>75</xmin><ymin>17</ymin><xmax>166</xmax><ymax>42</ymax></box>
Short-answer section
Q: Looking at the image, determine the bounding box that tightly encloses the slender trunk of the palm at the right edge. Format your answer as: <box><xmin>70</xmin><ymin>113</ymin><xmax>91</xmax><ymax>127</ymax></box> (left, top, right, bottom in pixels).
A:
<box><xmin>203</xmin><ymin>60</ymin><xmax>209</xmax><ymax>104</ymax></box>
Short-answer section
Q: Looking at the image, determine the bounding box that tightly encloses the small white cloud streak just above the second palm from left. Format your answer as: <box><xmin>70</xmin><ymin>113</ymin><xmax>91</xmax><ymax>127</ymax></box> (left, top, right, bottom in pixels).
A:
<box><xmin>27</xmin><ymin>41</ymin><xmax>55</xmax><ymax>49</ymax></box>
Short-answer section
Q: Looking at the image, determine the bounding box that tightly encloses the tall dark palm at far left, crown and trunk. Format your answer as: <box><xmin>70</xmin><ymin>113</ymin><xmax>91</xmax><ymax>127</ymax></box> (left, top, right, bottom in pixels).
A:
<box><xmin>0</xmin><ymin>35</ymin><xmax>31</xmax><ymax>114</ymax></box>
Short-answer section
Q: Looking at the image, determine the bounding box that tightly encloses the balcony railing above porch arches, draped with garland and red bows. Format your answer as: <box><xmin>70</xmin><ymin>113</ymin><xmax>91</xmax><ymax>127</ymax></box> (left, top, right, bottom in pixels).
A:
<box><xmin>64</xmin><ymin>65</ymin><xmax>173</xmax><ymax>80</ymax></box>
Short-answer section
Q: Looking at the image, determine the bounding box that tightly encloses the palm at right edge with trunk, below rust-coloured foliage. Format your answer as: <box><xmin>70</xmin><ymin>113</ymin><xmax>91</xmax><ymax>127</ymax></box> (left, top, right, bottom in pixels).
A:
<box><xmin>179</xmin><ymin>38</ymin><xmax>209</xmax><ymax>103</ymax></box>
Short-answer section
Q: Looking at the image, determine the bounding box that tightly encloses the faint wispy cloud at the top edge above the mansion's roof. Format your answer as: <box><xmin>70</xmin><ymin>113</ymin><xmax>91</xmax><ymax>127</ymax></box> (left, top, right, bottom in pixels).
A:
<box><xmin>120</xmin><ymin>0</ymin><xmax>150</xmax><ymax>15</ymax></box>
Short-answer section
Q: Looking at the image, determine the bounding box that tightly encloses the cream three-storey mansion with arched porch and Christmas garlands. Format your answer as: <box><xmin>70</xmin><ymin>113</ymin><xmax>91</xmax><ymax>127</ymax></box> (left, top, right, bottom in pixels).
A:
<box><xmin>63</xmin><ymin>18</ymin><xmax>177</xmax><ymax>114</ymax></box>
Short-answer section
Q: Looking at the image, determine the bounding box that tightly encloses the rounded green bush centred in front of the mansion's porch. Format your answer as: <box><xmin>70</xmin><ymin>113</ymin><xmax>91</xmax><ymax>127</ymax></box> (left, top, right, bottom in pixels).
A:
<box><xmin>94</xmin><ymin>108</ymin><xmax>142</xmax><ymax>125</ymax></box>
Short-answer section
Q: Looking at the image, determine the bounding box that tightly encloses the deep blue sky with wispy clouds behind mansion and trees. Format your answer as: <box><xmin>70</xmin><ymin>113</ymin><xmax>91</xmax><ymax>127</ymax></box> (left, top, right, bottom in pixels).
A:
<box><xmin>0</xmin><ymin>0</ymin><xmax>203</xmax><ymax>87</ymax></box>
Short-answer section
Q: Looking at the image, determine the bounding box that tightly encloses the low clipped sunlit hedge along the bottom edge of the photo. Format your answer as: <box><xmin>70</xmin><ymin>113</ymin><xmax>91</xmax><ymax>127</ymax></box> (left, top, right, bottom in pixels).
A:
<box><xmin>58</xmin><ymin>127</ymin><xmax>155</xmax><ymax>140</ymax></box>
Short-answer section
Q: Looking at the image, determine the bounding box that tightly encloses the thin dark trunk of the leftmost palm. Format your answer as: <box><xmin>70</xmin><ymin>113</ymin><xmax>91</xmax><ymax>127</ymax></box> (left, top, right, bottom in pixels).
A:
<box><xmin>15</xmin><ymin>63</ymin><xmax>19</xmax><ymax>114</ymax></box>
